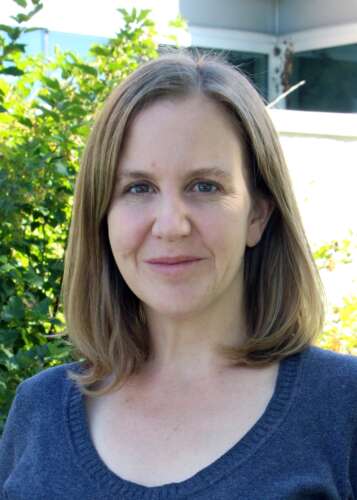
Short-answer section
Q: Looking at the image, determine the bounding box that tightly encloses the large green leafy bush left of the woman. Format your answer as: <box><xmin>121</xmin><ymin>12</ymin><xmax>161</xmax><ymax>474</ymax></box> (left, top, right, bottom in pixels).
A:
<box><xmin>0</xmin><ymin>0</ymin><xmax>157</xmax><ymax>432</ymax></box>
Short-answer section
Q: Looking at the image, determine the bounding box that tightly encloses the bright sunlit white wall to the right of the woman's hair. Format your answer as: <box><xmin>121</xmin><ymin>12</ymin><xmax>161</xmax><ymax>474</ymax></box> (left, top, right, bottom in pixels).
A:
<box><xmin>270</xmin><ymin>110</ymin><xmax>357</xmax><ymax>305</ymax></box>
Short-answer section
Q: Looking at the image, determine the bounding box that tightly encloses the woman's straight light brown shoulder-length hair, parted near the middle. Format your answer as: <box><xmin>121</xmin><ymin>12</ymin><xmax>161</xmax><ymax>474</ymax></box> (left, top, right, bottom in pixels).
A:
<box><xmin>62</xmin><ymin>51</ymin><xmax>324</xmax><ymax>396</ymax></box>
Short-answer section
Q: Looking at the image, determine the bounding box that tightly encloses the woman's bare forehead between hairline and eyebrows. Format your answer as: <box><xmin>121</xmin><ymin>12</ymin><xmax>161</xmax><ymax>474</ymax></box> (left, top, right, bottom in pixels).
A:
<box><xmin>122</xmin><ymin>94</ymin><xmax>242</xmax><ymax>159</ymax></box>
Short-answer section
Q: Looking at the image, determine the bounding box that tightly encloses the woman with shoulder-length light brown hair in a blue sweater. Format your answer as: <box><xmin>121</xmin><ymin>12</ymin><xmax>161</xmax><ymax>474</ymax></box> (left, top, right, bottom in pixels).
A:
<box><xmin>0</xmin><ymin>53</ymin><xmax>357</xmax><ymax>500</ymax></box>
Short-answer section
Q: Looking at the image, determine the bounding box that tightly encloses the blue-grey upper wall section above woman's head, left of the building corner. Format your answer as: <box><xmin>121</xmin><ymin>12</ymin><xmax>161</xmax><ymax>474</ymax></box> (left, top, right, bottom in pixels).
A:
<box><xmin>180</xmin><ymin>0</ymin><xmax>276</xmax><ymax>34</ymax></box>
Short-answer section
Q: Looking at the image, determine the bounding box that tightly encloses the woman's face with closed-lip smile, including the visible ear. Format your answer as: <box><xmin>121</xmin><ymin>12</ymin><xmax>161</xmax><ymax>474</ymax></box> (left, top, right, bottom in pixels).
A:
<box><xmin>108</xmin><ymin>96</ymin><xmax>268</xmax><ymax>317</ymax></box>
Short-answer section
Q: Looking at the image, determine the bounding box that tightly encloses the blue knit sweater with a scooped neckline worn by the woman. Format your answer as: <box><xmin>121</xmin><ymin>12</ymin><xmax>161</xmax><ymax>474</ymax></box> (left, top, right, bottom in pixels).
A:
<box><xmin>0</xmin><ymin>347</ymin><xmax>357</xmax><ymax>500</ymax></box>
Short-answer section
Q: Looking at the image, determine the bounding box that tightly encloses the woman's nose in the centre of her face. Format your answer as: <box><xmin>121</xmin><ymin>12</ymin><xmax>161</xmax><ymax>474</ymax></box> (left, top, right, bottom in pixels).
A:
<box><xmin>152</xmin><ymin>195</ymin><xmax>191</xmax><ymax>240</ymax></box>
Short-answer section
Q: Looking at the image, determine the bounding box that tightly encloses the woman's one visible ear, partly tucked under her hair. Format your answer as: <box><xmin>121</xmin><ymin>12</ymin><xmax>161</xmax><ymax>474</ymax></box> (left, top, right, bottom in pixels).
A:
<box><xmin>246</xmin><ymin>196</ymin><xmax>274</xmax><ymax>247</ymax></box>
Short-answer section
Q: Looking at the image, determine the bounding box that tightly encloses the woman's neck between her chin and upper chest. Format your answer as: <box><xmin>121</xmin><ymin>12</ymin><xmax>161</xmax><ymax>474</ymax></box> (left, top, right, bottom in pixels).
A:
<box><xmin>140</xmin><ymin>292</ymin><xmax>246</xmax><ymax>381</ymax></box>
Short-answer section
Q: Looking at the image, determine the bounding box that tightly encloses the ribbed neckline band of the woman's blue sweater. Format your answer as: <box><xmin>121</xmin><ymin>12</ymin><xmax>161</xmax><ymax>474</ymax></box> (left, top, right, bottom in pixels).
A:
<box><xmin>66</xmin><ymin>351</ymin><xmax>306</xmax><ymax>500</ymax></box>
